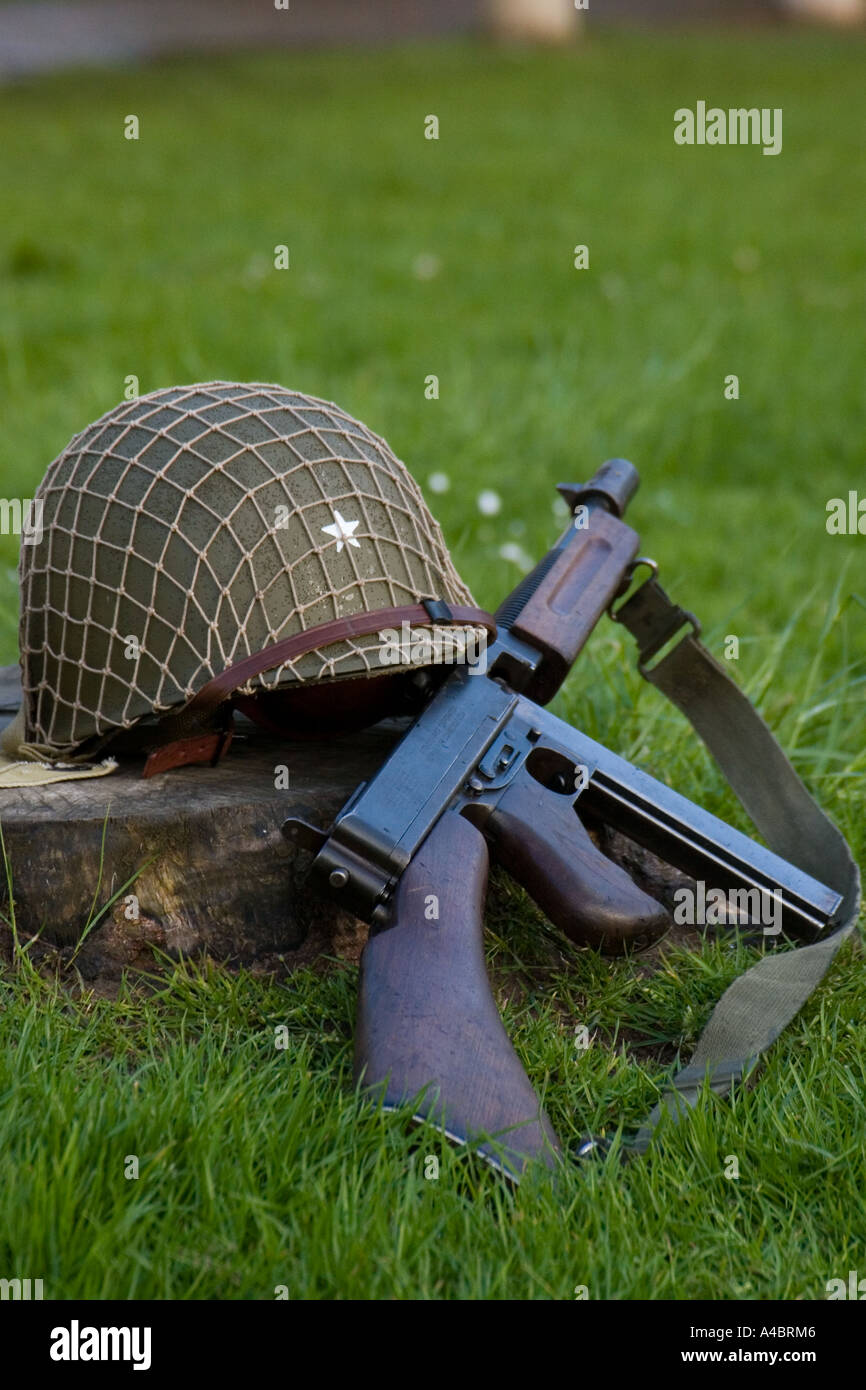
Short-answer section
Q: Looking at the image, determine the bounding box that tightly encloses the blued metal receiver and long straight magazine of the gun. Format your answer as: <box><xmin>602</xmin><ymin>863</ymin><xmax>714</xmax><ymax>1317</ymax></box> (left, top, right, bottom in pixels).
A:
<box><xmin>286</xmin><ymin>675</ymin><xmax>841</xmax><ymax>948</ymax></box>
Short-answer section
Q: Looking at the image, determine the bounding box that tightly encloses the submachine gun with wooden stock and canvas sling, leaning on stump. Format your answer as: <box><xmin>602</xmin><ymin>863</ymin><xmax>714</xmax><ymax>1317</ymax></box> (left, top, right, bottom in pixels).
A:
<box><xmin>284</xmin><ymin>459</ymin><xmax>858</xmax><ymax>1177</ymax></box>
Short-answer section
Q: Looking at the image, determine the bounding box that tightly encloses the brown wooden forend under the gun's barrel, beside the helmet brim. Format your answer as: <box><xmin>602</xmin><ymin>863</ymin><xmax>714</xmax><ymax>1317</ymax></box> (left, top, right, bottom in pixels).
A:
<box><xmin>512</xmin><ymin>507</ymin><xmax>639</xmax><ymax>705</ymax></box>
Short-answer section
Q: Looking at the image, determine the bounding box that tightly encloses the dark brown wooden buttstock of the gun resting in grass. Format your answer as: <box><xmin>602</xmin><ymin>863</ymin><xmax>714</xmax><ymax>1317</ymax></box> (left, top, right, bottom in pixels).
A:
<box><xmin>356</xmin><ymin>813</ymin><xmax>559</xmax><ymax>1176</ymax></box>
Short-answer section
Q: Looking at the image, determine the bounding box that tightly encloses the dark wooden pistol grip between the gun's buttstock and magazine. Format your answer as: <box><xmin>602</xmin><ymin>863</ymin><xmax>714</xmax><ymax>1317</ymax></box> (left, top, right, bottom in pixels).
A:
<box><xmin>485</xmin><ymin>774</ymin><xmax>669</xmax><ymax>955</ymax></box>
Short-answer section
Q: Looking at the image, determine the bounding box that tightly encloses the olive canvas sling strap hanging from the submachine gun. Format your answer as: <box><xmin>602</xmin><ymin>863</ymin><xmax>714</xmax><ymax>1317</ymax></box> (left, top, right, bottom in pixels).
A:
<box><xmin>610</xmin><ymin>562</ymin><xmax>860</xmax><ymax>1154</ymax></box>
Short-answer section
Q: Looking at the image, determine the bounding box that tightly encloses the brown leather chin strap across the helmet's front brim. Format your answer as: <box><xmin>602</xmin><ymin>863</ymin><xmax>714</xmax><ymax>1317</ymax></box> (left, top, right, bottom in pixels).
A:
<box><xmin>142</xmin><ymin>599</ymin><xmax>496</xmax><ymax>777</ymax></box>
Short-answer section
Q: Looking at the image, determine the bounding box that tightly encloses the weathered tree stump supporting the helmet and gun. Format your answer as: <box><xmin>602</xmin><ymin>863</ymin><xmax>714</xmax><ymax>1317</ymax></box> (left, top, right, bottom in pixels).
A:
<box><xmin>0</xmin><ymin>667</ymin><xmax>688</xmax><ymax>980</ymax></box>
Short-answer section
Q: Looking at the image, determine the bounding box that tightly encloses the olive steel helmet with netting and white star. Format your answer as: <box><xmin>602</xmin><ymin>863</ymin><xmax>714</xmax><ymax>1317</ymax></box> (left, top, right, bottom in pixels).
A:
<box><xmin>19</xmin><ymin>382</ymin><xmax>492</xmax><ymax>762</ymax></box>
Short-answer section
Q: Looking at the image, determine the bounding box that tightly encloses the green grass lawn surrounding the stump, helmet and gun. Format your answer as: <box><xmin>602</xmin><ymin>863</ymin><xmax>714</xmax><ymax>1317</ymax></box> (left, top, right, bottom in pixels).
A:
<box><xmin>0</xmin><ymin>33</ymin><xmax>866</xmax><ymax>1300</ymax></box>
